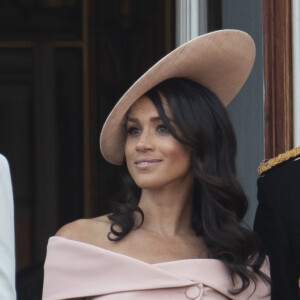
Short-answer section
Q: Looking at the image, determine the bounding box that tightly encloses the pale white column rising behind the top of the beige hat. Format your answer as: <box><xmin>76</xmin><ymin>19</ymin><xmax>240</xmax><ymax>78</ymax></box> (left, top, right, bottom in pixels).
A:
<box><xmin>176</xmin><ymin>0</ymin><xmax>207</xmax><ymax>46</ymax></box>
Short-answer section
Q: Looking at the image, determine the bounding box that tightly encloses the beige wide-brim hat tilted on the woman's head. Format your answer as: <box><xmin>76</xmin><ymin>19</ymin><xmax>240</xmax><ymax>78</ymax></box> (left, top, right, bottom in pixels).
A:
<box><xmin>100</xmin><ymin>30</ymin><xmax>255</xmax><ymax>165</ymax></box>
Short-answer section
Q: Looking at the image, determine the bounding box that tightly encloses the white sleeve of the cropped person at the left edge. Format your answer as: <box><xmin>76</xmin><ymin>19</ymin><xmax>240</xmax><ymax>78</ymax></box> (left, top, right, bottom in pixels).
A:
<box><xmin>0</xmin><ymin>154</ymin><xmax>16</xmax><ymax>300</ymax></box>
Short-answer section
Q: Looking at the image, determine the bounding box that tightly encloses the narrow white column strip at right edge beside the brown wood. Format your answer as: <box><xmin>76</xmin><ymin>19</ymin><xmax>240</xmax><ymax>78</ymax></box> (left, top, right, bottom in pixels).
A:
<box><xmin>292</xmin><ymin>0</ymin><xmax>300</xmax><ymax>147</ymax></box>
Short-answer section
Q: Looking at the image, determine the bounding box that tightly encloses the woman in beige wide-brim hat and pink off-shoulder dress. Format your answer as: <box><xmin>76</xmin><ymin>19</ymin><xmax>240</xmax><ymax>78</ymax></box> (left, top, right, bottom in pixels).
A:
<box><xmin>44</xmin><ymin>30</ymin><xmax>269</xmax><ymax>300</ymax></box>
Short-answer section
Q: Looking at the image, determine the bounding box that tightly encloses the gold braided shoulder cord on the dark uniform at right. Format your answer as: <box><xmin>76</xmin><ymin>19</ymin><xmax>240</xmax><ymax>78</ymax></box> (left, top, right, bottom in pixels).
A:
<box><xmin>257</xmin><ymin>147</ymin><xmax>300</xmax><ymax>176</ymax></box>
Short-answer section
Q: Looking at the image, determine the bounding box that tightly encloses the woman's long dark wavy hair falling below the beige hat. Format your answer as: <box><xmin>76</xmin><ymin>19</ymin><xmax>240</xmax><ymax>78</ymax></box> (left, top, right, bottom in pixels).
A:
<box><xmin>108</xmin><ymin>78</ymin><xmax>270</xmax><ymax>294</ymax></box>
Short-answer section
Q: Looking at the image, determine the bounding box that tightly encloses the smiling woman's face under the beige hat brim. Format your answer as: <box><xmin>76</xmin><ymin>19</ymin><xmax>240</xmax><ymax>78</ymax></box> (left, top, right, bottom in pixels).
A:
<box><xmin>125</xmin><ymin>96</ymin><xmax>194</xmax><ymax>189</ymax></box>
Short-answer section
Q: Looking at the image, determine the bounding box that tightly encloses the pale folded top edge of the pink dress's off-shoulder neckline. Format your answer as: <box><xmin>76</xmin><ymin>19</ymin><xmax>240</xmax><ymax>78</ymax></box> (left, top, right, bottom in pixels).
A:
<box><xmin>49</xmin><ymin>235</ymin><xmax>223</xmax><ymax>266</ymax></box>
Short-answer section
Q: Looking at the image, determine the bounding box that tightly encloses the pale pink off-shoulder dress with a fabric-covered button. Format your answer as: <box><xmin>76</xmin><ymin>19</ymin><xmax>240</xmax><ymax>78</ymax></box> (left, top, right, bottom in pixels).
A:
<box><xmin>43</xmin><ymin>237</ymin><xmax>270</xmax><ymax>300</ymax></box>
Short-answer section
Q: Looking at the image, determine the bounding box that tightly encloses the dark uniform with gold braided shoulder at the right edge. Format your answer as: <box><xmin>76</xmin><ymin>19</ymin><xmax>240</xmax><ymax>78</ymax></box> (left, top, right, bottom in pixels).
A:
<box><xmin>254</xmin><ymin>147</ymin><xmax>300</xmax><ymax>300</ymax></box>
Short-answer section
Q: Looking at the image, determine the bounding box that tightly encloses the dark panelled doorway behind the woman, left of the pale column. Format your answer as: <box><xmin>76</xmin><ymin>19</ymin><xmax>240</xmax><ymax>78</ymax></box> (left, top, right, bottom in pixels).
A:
<box><xmin>0</xmin><ymin>0</ymin><xmax>175</xmax><ymax>270</ymax></box>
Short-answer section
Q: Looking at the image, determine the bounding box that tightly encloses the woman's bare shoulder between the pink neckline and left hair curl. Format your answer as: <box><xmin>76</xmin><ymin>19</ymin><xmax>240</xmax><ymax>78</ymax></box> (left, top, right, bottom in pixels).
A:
<box><xmin>56</xmin><ymin>215</ymin><xmax>111</xmax><ymax>247</ymax></box>
